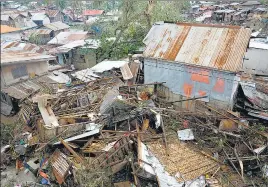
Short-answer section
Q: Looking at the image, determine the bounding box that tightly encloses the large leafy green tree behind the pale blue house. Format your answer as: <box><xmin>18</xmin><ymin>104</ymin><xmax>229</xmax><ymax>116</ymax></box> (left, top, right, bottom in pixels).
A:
<box><xmin>95</xmin><ymin>0</ymin><xmax>189</xmax><ymax>61</ymax></box>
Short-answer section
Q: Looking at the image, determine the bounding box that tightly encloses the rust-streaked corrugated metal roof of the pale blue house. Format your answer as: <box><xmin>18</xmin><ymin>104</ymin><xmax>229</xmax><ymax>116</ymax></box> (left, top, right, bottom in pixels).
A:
<box><xmin>143</xmin><ymin>23</ymin><xmax>251</xmax><ymax>72</ymax></box>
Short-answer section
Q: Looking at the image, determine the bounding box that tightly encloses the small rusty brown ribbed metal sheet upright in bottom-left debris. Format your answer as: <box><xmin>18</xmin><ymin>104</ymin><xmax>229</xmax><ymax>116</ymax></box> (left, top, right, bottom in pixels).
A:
<box><xmin>51</xmin><ymin>150</ymin><xmax>70</xmax><ymax>184</ymax></box>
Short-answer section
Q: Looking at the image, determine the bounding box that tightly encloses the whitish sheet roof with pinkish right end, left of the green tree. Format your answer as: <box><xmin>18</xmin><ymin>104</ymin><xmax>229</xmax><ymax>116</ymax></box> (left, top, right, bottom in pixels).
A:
<box><xmin>48</xmin><ymin>31</ymin><xmax>88</xmax><ymax>45</ymax></box>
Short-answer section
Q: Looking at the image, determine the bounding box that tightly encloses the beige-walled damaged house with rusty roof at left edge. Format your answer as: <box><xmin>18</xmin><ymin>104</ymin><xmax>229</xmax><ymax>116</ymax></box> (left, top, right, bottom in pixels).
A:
<box><xmin>1</xmin><ymin>42</ymin><xmax>55</xmax><ymax>115</ymax></box>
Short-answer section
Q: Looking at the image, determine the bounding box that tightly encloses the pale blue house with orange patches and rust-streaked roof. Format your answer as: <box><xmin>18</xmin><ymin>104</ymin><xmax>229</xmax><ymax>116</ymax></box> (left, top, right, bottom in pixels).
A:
<box><xmin>143</xmin><ymin>23</ymin><xmax>251</xmax><ymax>108</ymax></box>
